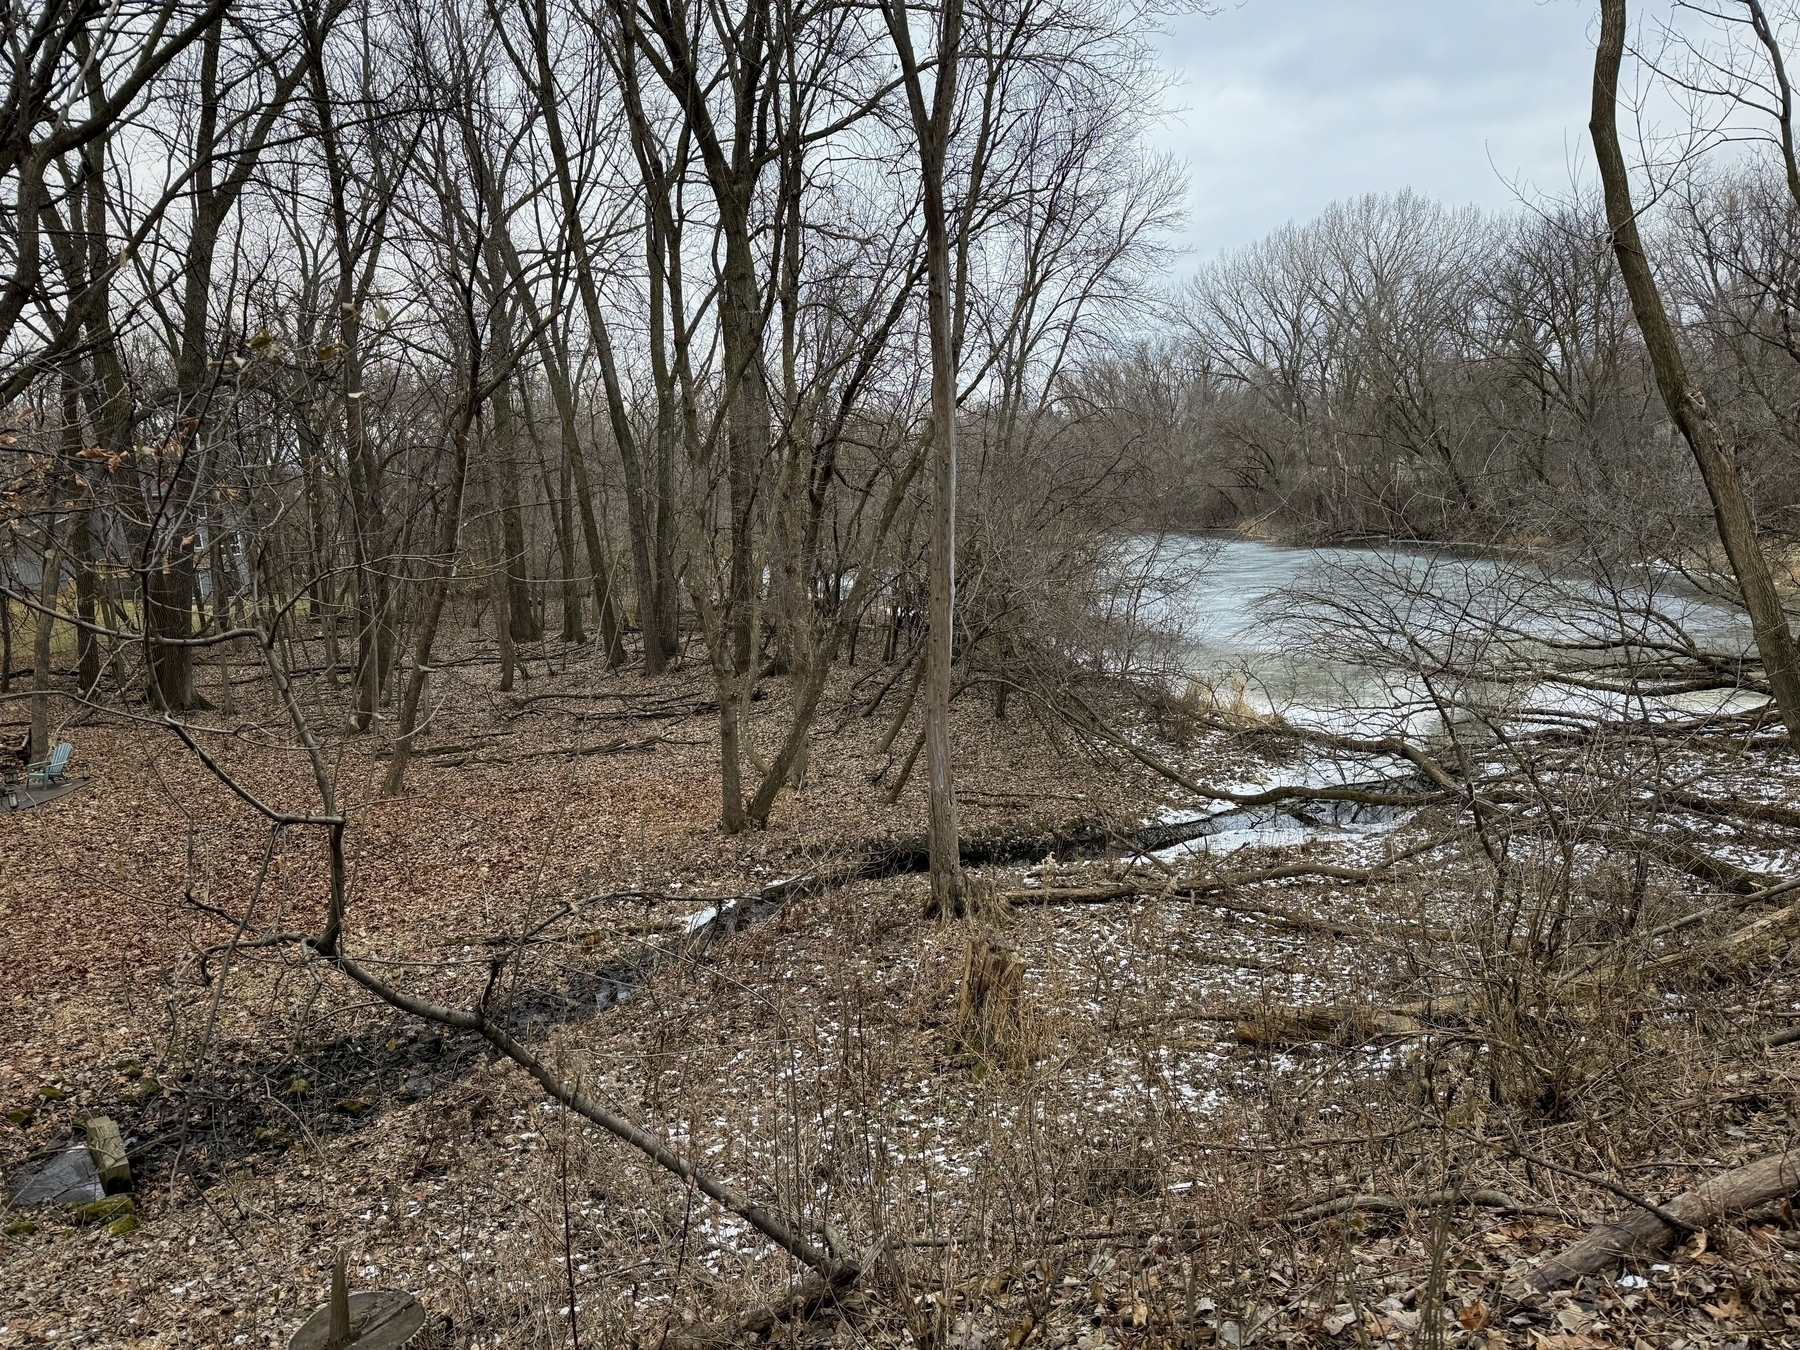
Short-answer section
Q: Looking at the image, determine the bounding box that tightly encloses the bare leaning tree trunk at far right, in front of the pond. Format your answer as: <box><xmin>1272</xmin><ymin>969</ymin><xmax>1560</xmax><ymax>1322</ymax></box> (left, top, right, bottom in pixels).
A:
<box><xmin>1588</xmin><ymin>0</ymin><xmax>1800</xmax><ymax>745</ymax></box>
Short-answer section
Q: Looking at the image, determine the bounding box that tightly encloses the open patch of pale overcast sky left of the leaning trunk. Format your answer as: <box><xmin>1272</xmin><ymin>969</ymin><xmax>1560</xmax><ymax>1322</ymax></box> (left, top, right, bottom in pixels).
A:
<box><xmin>1156</xmin><ymin>0</ymin><xmax>1595</xmax><ymax>266</ymax></box>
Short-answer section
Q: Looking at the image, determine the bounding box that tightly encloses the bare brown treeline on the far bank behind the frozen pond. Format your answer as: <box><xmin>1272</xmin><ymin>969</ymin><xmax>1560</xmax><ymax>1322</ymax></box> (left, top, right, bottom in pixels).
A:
<box><xmin>1071</xmin><ymin>180</ymin><xmax>1800</xmax><ymax>554</ymax></box>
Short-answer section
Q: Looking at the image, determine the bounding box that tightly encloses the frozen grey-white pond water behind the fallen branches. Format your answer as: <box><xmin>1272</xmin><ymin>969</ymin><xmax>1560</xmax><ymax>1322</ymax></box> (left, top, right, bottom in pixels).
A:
<box><xmin>1136</xmin><ymin>535</ymin><xmax>1762</xmax><ymax>736</ymax></box>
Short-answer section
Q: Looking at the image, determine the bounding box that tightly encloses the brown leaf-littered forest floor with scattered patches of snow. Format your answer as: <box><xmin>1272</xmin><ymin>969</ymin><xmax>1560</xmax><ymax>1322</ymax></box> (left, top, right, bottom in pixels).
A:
<box><xmin>0</xmin><ymin>630</ymin><xmax>1800</xmax><ymax>1350</ymax></box>
